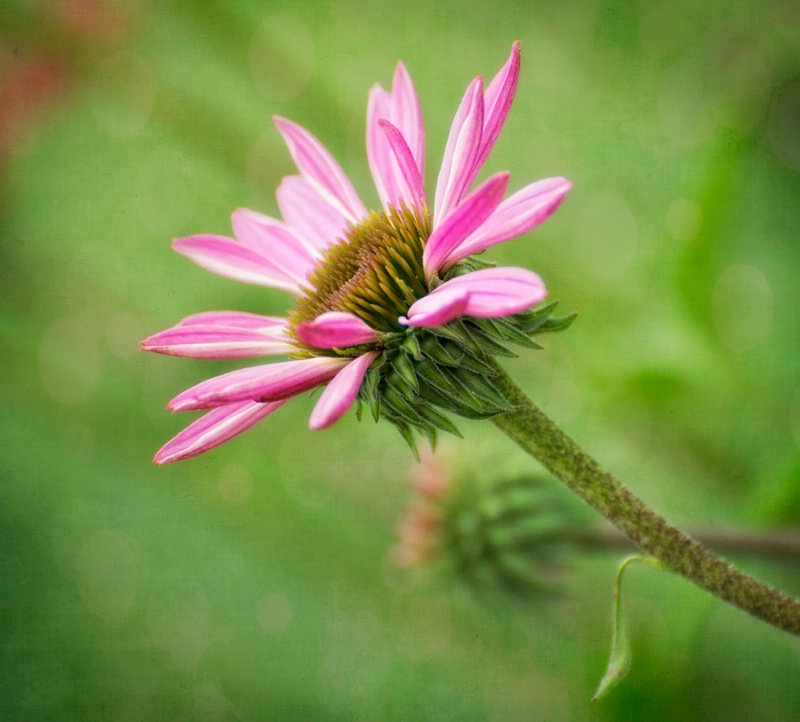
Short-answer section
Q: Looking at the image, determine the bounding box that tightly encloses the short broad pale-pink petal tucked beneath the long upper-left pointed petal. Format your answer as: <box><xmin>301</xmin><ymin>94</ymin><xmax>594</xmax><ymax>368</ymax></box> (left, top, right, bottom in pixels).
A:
<box><xmin>276</xmin><ymin>176</ymin><xmax>347</xmax><ymax>251</ymax></box>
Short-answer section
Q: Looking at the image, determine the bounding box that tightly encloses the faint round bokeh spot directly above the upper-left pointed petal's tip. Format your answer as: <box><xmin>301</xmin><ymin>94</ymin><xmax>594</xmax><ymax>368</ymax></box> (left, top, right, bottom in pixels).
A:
<box><xmin>248</xmin><ymin>12</ymin><xmax>314</xmax><ymax>101</ymax></box>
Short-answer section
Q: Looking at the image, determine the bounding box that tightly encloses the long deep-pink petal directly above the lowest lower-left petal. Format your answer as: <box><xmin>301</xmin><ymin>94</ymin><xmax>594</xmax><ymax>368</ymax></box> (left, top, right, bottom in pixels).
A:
<box><xmin>167</xmin><ymin>357</ymin><xmax>349</xmax><ymax>411</ymax></box>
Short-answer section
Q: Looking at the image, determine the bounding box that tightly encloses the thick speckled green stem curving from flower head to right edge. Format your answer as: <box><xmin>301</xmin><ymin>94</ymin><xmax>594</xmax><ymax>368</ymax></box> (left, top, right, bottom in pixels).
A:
<box><xmin>492</xmin><ymin>366</ymin><xmax>800</xmax><ymax>636</ymax></box>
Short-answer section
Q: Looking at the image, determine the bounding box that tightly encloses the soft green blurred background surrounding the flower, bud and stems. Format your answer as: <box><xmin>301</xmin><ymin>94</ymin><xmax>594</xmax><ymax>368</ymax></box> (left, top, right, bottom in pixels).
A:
<box><xmin>0</xmin><ymin>0</ymin><xmax>800</xmax><ymax>722</ymax></box>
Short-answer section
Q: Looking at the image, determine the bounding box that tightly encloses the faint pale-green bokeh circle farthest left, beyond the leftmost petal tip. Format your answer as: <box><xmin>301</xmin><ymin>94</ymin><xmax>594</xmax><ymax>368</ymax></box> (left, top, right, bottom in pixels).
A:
<box><xmin>39</xmin><ymin>317</ymin><xmax>101</xmax><ymax>406</ymax></box>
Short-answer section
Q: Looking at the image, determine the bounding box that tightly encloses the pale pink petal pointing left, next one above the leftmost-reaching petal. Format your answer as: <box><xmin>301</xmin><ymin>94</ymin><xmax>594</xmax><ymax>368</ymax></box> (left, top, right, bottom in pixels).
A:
<box><xmin>172</xmin><ymin>235</ymin><xmax>302</xmax><ymax>295</ymax></box>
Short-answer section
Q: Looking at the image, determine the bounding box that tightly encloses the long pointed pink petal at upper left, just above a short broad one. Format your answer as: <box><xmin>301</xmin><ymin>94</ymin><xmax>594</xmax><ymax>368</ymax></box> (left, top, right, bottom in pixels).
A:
<box><xmin>273</xmin><ymin>116</ymin><xmax>367</xmax><ymax>223</ymax></box>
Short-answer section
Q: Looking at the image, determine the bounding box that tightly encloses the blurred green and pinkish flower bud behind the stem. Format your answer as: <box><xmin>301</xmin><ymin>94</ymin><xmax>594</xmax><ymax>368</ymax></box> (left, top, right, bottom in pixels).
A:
<box><xmin>392</xmin><ymin>449</ymin><xmax>588</xmax><ymax>601</ymax></box>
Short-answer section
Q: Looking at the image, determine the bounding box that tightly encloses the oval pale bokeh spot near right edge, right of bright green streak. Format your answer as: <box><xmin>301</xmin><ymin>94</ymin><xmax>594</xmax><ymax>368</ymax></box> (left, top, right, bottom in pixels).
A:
<box><xmin>713</xmin><ymin>264</ymin><xmax>773</xmax><ymax>350</ymax></box>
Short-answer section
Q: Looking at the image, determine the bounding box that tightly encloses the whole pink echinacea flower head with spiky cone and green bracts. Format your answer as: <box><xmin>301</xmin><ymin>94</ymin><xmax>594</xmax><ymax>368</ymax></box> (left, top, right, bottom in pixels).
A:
<box><xmin>142</xmin><ymin>43</ymin><xmax>571</xmax><ymax>463</ymax></box>
